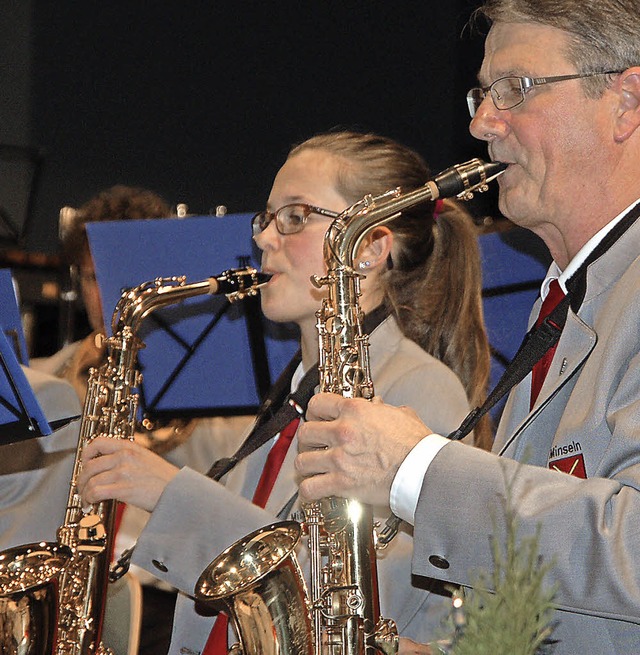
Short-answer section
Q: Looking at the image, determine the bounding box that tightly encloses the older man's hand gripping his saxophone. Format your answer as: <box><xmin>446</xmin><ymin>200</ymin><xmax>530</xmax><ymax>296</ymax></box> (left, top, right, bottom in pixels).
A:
<box><xmin>296</xmin><ymin>393</ymin><xmax>431</xmax><ymax>505</ymax></box>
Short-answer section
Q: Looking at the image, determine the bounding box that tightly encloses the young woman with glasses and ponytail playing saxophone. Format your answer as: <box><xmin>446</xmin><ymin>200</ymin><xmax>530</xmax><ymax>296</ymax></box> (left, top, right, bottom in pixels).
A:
<box><xmin>79</xmin><ymin>132</ymin><xmax>489</xmax><ymax>653</ymax></box>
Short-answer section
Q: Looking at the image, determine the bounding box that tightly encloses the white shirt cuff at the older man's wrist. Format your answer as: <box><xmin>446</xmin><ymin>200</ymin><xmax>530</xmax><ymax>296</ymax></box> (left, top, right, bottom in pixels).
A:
<box><xmin>389</xmin><ymin>434</ymin><xmax>451</xmax><ymax>525</ymax></box>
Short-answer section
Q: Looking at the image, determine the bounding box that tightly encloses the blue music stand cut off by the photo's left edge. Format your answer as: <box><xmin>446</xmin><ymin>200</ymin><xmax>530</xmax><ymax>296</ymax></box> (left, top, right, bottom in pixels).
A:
<box><xmin>0</xmin><ymin>269</ymin><xmax>53</xmax><ymax>445</ymax></box>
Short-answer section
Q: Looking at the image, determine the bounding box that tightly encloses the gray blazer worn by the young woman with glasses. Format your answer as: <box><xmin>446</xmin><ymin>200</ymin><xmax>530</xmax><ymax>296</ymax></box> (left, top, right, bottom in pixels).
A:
<box><xmin>133</xmin><ymin>319</ymin><xmax>467</xmax><ymax>655</ymax></box>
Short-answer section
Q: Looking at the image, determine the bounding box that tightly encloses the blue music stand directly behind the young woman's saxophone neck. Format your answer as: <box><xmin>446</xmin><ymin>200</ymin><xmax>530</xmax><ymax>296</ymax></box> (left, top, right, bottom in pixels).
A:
<box><xmin>87</xmin><ymin>214</ymin><xmax>298</xmax><ymax>419</ymax></box>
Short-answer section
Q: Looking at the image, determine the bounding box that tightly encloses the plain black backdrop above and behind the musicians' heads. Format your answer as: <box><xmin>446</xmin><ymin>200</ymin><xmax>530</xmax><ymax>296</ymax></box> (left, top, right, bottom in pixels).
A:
<box><xmin>25</xmin><ymin>0</ymin><xmax>496</xmax><ymax>252</ymax></box>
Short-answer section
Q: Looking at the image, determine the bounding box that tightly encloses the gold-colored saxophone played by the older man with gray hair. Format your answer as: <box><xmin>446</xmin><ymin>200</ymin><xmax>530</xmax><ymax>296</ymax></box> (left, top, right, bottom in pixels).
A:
<box><xmin>195</xmin><ymin>159</ymin><xmax>506</xmax><ymax>655</ymax></box>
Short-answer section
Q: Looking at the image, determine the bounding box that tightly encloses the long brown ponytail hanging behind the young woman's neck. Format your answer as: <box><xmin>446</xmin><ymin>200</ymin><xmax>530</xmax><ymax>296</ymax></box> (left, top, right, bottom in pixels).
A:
<box><xmin>384</xmin><ymin>200</ymin><xmax>493</xmax><ymax>449</ymax></box>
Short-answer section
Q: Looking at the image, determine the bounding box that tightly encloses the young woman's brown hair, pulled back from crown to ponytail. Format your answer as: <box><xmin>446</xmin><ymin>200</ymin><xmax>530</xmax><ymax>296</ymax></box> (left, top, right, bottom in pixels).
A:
<box><xmin>289</xmin><ymin>131</ymin><xmax>492</xmax><ymax>448</ymax></box>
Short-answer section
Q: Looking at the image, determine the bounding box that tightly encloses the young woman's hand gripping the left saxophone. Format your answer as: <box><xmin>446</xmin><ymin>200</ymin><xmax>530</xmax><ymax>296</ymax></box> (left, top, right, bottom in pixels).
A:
<box><xmin>78</xmin><ymin>437</ymin><xmax>179</xmax><ymax>512</ymax></box>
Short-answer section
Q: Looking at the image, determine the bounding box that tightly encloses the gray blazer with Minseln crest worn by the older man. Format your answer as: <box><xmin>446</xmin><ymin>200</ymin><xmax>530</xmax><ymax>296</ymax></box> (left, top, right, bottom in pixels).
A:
<box><xmin>413</xmin><ymin>221</ymin><xmax>640</xmax><ymax>655</ymax></box>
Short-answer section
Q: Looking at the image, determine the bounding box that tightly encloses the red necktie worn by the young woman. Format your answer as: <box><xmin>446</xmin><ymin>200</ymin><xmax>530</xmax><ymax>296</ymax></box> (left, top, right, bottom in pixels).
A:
<box><xmin>202</xmin><ymin>416</ymin><xmax>300</xmax><ymax>655</ymax></box>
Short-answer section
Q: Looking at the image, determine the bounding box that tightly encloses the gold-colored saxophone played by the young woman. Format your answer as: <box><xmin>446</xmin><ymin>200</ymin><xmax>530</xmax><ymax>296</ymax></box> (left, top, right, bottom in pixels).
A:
<box><xmin>0</xmin><ymin>267</ymin><xmax>269</xmax><ymax>655</ymax></box>
